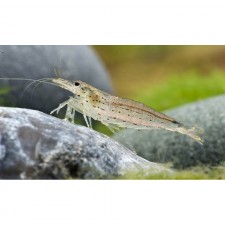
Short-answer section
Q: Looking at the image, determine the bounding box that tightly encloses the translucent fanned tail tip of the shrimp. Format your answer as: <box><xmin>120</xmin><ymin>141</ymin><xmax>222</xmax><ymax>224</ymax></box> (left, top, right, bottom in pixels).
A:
<box><xmin>177</xmin><ymin>127</ymin><xmax>204</xmax><ymax>145</ymax></box>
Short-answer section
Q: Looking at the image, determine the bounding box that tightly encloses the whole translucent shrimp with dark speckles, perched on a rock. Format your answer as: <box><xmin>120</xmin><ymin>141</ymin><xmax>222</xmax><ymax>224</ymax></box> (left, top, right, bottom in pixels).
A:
<box><xmin>51</xmin><ymin>78</ymin><xmax>202</xmax><ymax>143</ymax></box>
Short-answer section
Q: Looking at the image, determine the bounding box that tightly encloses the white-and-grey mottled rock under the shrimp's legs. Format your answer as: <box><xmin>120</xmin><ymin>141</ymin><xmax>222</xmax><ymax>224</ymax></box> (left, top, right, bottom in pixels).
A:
<box><xmin>0</xmin><ymin>107</ymin><xmax>170</xmax><ymax>179</ymax></box>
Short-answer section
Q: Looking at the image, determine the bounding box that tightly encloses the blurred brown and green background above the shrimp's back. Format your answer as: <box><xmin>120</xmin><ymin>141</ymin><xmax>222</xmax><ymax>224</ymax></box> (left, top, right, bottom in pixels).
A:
<box><xmin>92</xmin><ymin>45</ymin><xmax>225</xmax><ymax>111</ymax></box>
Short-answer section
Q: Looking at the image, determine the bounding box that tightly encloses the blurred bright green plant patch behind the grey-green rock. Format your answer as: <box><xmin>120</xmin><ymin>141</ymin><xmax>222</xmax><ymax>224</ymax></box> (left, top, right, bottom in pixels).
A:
<box><xmin>134</xmin><ymin>71</ymin><xmax>225</xmax><ymax>111</ymax></box>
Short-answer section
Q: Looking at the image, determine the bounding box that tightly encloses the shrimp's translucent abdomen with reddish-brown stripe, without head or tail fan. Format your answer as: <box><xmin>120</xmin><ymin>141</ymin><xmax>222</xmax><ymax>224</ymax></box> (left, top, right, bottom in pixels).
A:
<box><xmin>94</xmin><ymin>96</ymin><xmax>181</xmax><ymax>129</ymax></box>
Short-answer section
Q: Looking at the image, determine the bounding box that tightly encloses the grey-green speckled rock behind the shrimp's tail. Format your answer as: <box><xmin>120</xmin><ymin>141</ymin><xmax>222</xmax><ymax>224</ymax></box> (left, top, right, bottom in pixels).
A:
<box><xmin>114</xmin><ymin>95</ymin><xmax>225</xmax><ymax>169</ymax></box>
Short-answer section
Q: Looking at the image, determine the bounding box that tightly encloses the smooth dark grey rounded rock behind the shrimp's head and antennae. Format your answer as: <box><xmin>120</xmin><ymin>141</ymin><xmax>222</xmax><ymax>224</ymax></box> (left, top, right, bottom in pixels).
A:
<box><xmin>0</xmin><ymin>45</ymin><xmax>113</xmax><ymax>113</ymax></box>
